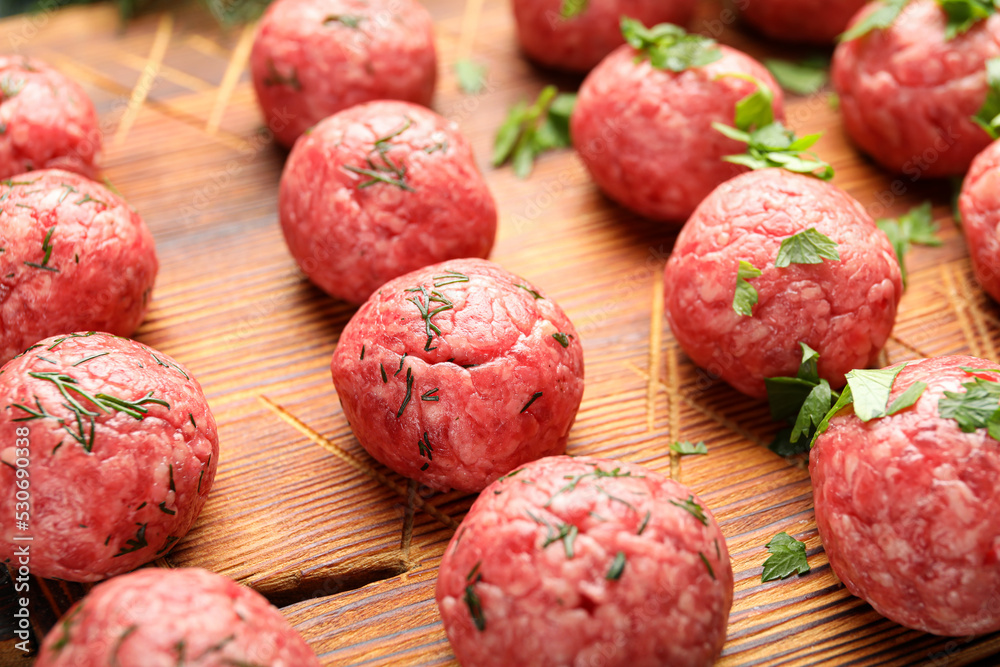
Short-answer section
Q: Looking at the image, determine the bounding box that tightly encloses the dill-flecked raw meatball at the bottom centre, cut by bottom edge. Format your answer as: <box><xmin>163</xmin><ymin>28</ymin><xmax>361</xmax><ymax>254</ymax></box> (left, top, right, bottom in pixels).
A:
<box><xmin>437</xmin><ymin>456</ymin><xmax>733</xmax><ymax>667</ymax></box>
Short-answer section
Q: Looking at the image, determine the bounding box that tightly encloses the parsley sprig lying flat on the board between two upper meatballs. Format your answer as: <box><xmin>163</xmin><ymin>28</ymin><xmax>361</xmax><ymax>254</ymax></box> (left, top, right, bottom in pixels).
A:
<box><xmin>493</xmin><ymin>86</ymin><xmax>576</xmax><ymax>178</ymax></box>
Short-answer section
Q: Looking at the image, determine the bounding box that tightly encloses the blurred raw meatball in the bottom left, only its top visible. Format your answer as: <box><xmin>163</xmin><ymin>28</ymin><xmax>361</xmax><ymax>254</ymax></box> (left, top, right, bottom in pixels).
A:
<box><xmin>35</xmin><ymin>568</ymin><xmax>319</xmax><ymax>667</ymax></box>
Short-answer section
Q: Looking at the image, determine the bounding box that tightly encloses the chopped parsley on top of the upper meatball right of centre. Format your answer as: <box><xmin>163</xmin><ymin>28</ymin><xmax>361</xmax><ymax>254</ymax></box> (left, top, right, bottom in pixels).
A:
<box><xmin>621</xmin><ymin>16</ymin><xmax>722</xmax><ymax>72</ymax></box>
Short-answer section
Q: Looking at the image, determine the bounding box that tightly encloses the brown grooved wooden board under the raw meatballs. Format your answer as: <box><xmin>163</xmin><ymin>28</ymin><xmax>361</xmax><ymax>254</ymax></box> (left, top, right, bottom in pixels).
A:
<box><xmin>0</xmin><ymin>0</ymin><xmax>1000</xmax><ymax>666</ymax></box>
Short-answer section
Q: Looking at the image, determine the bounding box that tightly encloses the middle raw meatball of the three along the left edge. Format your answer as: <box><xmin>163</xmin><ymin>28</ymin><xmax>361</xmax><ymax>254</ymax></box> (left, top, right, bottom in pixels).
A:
<box><xmin>0</xmin><ymin>169</ymin><xmax>159</xmax><ymax>363</ymax></box>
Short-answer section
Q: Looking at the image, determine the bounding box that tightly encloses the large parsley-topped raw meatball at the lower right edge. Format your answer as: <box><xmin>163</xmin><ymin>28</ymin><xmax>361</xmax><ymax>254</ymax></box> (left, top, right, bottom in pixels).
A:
<box><xmin>809</xmin><ymin>357</ymin><xmax>1000</xmax><ymax>637</ymax></box>
